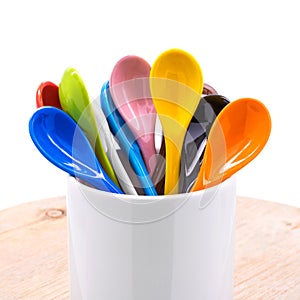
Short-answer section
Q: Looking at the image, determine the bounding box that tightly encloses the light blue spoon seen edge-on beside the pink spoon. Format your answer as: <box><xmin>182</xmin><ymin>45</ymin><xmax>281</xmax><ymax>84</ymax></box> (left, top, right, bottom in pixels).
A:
<box><xmin>100</xmin><ymin>82</ymin><xmax>157</xmax><ymax>196</ymax></box>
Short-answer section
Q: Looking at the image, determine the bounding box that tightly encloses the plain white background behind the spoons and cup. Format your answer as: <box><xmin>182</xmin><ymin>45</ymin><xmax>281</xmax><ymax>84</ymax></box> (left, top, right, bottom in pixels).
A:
<box><xmin>0</xmin><ymin>0</ymin><xmax>300</xmax><ymax>209</ymax></box>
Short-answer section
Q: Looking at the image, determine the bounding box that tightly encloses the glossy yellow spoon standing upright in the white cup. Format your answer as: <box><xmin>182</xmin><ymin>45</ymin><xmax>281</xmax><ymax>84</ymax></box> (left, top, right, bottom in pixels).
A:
<box><xmin>150</xmin><ymin>49</ymin><xmax>203</xmax><ymax>194</ymax></box>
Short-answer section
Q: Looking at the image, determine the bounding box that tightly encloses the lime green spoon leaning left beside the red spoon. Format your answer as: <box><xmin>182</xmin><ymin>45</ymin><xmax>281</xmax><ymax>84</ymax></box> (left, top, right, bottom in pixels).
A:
<box><xmin>59</xmin><ymin>68</ymin><xmax>119</xmax><ymax>185</ymax></box>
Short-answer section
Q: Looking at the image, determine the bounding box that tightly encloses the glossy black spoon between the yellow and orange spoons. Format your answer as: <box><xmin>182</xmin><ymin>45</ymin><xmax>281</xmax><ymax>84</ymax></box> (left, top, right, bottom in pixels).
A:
<box><xmin>179</xmin><ymin>94</ymin><xmax>229</xmax><ymax>193</ymax></box>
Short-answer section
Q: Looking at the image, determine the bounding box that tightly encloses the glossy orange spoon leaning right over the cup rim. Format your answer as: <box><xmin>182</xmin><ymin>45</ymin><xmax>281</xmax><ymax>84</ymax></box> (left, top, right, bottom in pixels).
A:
<box><xmin>192</xmin><ymin>98</ymin><xmax>271</xmax><ymax>191</ymax></box>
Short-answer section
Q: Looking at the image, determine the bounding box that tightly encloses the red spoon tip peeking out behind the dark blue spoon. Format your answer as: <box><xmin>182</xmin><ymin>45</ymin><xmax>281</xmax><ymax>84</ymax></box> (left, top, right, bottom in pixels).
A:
<box><xmin>36</xmin><ymin>81</ymin><xmax>61</xmax><ymax>109</ymax></box>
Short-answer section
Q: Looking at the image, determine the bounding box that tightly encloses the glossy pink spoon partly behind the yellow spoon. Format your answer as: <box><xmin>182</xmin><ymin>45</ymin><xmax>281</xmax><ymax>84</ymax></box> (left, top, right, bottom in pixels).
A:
<box><xmin>110</xmin><ymin>55</ymin><xmax>157</xmax><ymax>175</ymax></box>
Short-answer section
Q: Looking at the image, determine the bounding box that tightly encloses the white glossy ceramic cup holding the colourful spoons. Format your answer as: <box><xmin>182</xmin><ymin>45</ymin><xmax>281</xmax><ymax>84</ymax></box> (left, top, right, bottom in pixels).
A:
<box><xmin>67</xmin><ymin>177</ymin><xmax>236</xmax><ymax>300</ymax></box>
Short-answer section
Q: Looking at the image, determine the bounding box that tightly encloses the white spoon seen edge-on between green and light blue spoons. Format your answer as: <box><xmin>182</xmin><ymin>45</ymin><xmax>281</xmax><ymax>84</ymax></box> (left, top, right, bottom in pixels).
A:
<box><xmin>92</xmin><ymin>99</ymin><xmax>137</xmax><ymax>195</ymax></box>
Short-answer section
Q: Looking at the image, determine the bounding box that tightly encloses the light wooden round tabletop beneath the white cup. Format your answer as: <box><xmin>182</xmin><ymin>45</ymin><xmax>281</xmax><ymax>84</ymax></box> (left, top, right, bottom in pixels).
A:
<box><xmin>0</xmin><ymin>197</ymin><xmax>300</xmax><ymax>300</ymax></box>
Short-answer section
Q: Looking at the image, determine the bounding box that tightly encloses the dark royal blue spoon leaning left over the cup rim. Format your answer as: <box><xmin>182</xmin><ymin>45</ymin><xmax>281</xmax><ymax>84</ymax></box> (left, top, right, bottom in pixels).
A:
<box><xmin>29</xmin><ymin>106</ymin><xmax>123</xmax><ymax>194</ymax></box>
